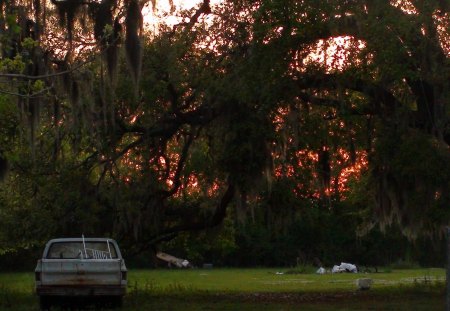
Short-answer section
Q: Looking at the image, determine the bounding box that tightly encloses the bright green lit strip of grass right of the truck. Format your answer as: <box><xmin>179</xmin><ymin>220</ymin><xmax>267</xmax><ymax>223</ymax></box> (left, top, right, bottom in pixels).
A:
<box><xmin>130</xmin><ymin>269</ymin><xmax>445</xmax><ymax>293</ymax></box>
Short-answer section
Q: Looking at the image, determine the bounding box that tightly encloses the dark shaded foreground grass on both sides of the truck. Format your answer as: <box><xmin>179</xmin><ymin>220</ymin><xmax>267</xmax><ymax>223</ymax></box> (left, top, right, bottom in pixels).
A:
<box><xmin>0</xmin><ymin>279</ymin><xmax>445</xmax><ymax>311</ymax></box>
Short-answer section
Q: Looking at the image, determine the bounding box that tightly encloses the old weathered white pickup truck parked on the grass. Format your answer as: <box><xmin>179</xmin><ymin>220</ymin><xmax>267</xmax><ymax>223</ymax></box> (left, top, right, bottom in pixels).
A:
<box><xmin>35</xmin><ymin>237</ymin><xmax>127</xmax><ymax>310</ymax></box>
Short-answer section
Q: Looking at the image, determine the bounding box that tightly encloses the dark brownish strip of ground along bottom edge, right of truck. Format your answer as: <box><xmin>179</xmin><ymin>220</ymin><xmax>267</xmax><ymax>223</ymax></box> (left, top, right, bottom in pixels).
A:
<box><xmin>125</xmin><ymin>289</ymin><xmax>445</xmax><ymax>311</ymax></box>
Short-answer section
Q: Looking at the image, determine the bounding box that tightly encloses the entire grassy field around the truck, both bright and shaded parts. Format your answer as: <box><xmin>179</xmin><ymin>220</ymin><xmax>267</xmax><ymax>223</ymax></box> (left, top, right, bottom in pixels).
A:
<box><xmin>0</xmin><ymin>269</ymin><xmax>445</xmax><ymax>311</ymax></box>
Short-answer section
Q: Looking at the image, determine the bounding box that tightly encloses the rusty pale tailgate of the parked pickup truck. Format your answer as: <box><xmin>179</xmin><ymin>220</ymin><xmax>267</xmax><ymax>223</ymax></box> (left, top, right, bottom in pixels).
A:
<box><xmin>41</xmin><ymin>259</ymin><xmax>122</xmax><ymax>286</ymax></box>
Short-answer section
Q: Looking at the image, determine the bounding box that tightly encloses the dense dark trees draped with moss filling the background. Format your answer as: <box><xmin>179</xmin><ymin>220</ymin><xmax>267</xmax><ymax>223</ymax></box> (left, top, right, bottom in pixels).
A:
<box><xmin>0</xmin><ymin>0</ymin><xmax>450</xmax><ymax>265</ymax></box>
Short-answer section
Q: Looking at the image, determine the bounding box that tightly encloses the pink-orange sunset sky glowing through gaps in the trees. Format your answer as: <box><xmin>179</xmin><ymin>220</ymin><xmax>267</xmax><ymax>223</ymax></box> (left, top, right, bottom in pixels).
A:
<box><xmin>108</xmin><ymin>0</ymin><xmax>449</xmax><ymax>202</ymax></box>
